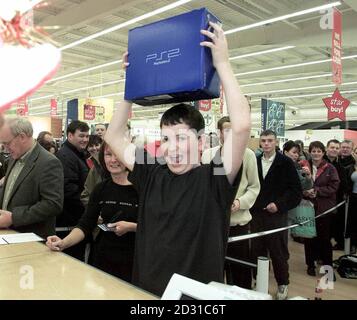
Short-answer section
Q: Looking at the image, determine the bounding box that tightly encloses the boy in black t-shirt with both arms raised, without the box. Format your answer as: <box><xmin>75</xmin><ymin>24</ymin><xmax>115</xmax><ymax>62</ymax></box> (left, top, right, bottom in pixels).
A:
<box><xmin>105</xmin><ymin>23</ymin><xmax>251</xmax><ymax>295</ymax></box>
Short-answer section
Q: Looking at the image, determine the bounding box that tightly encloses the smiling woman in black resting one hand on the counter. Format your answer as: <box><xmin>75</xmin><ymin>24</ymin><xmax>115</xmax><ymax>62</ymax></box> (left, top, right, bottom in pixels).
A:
<box><xmin>46</xmin><ymin>142</ymin><xmax>138</xmax><ymax>281</ymax></box>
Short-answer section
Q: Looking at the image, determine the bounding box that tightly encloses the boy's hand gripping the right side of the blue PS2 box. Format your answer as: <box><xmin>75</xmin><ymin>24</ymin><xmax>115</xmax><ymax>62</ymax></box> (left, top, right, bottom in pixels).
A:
<box><xmin>200</xmin><ymin>22</ymin><xmax>229</xmax><ymax>68</ymax></box>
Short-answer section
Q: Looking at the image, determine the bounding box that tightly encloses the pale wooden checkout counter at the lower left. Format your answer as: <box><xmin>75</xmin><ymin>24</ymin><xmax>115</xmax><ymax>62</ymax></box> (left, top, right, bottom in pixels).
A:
<box><xmin>0</xmin><ymin>230</ymin><xmax>159</xmax><ymax>300</ymax></box>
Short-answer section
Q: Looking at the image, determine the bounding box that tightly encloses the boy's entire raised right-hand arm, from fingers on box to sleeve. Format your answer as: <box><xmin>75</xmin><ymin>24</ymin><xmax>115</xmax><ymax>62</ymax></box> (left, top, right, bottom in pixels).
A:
<box><xmin>201</xmin><ymin>22</ymin><xmax>251</xmax><ymax>184</ymax></box>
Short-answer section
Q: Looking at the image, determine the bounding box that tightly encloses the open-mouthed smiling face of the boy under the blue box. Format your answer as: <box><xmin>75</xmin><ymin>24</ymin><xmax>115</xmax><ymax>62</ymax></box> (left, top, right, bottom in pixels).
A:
<box><xmin>160</xmin><ymin>123</ymin><xmax>204</xmax><ymax>174</ymax></box>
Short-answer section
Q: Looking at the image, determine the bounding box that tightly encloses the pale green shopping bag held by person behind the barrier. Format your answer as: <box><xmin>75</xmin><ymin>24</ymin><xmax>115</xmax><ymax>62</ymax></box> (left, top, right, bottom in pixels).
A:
<box><xmin>289</xmin><ymin>199</ymin><xmax>316</xmax><ymax>238</ymax></box>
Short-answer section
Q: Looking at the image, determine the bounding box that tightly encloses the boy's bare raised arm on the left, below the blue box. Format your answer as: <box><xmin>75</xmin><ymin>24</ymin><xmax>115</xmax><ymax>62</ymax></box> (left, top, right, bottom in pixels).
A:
<box><xmin>104</xmin><ymin>100</ymin><xmax>135</xmax><ymax>171</ymax></box>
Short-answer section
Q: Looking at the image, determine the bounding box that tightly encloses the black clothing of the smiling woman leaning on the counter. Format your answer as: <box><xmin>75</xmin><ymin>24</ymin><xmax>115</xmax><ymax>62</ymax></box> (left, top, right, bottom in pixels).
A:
<box><xmin>77</xmin><ymin>178</ymin><xmax>139</xmax><ymax>281</ymax></box>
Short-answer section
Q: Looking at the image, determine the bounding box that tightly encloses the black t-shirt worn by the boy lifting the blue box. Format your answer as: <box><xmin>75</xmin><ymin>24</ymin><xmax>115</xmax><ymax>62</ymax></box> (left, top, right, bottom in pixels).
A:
<box><xmin>128</xmin><ymin>150</ymin><xmax>241</xmax><ymax>295</ymax></box>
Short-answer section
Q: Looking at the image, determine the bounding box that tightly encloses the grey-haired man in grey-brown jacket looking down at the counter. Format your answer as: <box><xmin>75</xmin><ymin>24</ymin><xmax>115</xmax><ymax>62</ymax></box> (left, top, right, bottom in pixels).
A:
<box><xmin>0</xmin><ymin>118</ymin><xmax>63</xmax><ymax>238</ymax></box>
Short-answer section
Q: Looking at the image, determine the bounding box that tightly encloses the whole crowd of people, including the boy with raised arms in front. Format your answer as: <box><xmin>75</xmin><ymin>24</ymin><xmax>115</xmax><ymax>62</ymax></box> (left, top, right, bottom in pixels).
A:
<box><xmin>0</xmin><ymin>24</ymin><xmax>357</xmax><ymax>299</ymax></box>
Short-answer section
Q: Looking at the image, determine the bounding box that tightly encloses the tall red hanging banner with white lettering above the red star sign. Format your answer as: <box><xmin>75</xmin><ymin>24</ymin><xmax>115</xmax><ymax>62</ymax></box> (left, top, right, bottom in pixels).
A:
<box><xmin>332</xmin><ymin>8</ymin><xmax>342</xmax><ymax>85</ymax></box>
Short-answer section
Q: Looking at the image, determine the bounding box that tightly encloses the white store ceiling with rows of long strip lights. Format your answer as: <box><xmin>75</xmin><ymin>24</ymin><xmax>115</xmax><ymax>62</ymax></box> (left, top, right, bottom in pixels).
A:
<box><xmin>13</xmin><ymin>0</ymin><xmax>357</xmax><ymax>130</ymax></box>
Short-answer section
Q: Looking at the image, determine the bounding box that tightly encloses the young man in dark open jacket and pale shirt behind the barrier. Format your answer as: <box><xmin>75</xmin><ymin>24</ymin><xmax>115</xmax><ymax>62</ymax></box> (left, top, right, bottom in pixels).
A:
<box><xmin>251</xmin><ymin>130</ymin><xmax>302</xmax><ymax>299</ymax></box>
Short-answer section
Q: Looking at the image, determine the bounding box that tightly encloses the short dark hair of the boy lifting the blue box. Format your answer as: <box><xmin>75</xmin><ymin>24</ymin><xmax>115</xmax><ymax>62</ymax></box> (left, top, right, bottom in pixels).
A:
<box><xmin>160</xmin><ymin>103</ymin><xmax>205</xmax><ymax>134</ymax></box>
